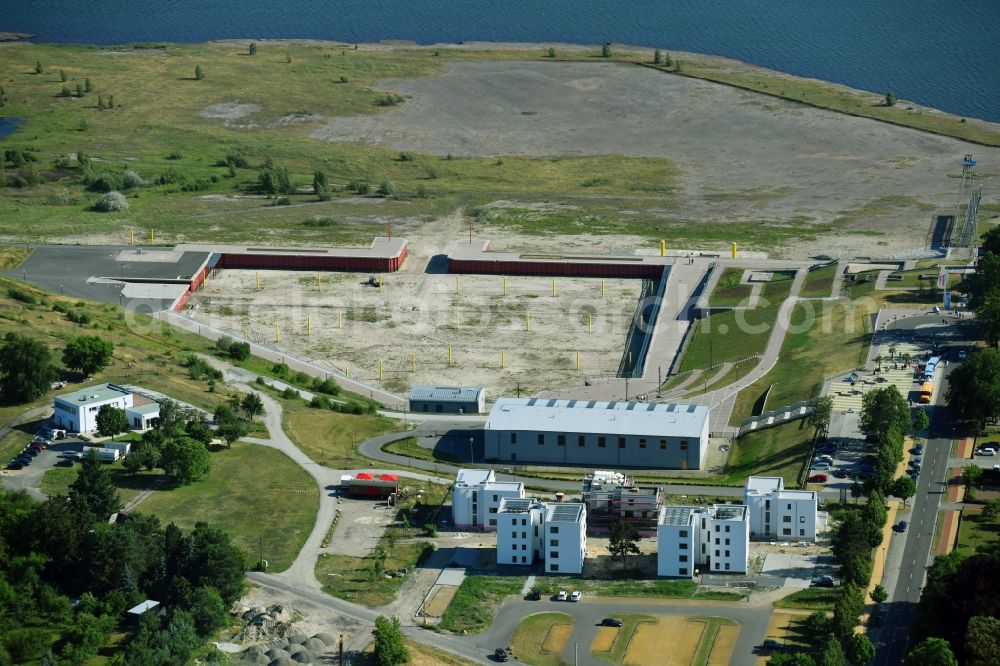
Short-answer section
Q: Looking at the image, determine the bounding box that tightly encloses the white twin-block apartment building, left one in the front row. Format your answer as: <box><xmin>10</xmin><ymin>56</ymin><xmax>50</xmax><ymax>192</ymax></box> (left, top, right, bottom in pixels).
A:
<box><xmin>496</xmin><ymin>497</ymin><xmax>587</xmax><ymax>574</ymax></box>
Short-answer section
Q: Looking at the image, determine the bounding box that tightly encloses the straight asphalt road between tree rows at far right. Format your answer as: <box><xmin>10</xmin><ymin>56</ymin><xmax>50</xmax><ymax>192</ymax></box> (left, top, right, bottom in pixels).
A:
<box><xmin>874</xmin><ymin>338</ymin><xmax>954</xmax><ymax>666</ymax></box>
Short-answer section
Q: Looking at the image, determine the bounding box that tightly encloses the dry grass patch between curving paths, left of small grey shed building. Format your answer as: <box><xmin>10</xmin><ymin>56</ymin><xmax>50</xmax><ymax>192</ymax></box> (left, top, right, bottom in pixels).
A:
<box><xmin>282</xmin><ymin>400</ymin><xmax>402</xmax><ymax>469</ymax></box>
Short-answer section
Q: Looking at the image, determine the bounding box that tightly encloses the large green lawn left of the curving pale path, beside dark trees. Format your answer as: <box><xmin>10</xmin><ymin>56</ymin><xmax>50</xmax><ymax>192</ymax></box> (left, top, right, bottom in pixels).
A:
<box><xmin>137</xmin><ymin>443</ymin><xmax>319</xmax><ymax>571</ymax></box>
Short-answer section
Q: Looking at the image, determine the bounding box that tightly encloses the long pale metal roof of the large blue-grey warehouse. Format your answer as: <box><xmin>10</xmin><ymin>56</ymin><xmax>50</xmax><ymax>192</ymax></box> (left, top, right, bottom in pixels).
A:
<box><xmin>486</xmin><ymin>398</ymin><xmax>708</xmax><ymax>437</ymax></box>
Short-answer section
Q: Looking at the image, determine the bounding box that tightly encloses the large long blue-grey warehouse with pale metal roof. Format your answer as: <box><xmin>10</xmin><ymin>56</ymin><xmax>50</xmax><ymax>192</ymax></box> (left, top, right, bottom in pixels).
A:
<box><xmin>484</xmin><ymin>398</ymin><xmax>709</xmax><ymax>469</ymax></box>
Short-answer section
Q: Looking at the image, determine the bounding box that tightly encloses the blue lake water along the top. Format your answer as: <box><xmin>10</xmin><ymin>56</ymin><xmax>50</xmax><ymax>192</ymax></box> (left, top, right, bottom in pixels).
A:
<box><xmin>7</xmin><ymin>0</ymin><xmax>1000</xmax><ymax>122</ymax></box>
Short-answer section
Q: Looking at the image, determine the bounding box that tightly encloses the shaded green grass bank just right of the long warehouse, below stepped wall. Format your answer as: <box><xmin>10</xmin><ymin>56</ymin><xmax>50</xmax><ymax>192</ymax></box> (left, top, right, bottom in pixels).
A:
<box><xmin>726</xmin><ymin>419</ymin><xmax>813</xmax><ymax>488</ymax></box>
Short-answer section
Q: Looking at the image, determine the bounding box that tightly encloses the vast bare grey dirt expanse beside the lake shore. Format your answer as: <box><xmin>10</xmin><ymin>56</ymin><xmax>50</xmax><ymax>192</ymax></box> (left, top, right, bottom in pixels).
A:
<box><xmin>313</xmin><ymin>61</ymin><xmax>1000</xmax><ymax>256</ymax></box>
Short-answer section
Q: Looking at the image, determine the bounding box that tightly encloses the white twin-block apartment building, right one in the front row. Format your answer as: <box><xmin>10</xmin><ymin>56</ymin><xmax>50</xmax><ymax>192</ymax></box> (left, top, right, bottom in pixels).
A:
<box><xmin>656</xmin><ymin>504</ymin><xmax>750</xmax><ymax>578</ymax></box>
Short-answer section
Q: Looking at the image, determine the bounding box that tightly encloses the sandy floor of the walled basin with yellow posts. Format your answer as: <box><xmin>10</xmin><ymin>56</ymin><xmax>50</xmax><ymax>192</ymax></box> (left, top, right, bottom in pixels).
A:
<box><xmin>189</xmin><ymin>270</ymin><xmax>641</xmax><ymax>395</ymax></box>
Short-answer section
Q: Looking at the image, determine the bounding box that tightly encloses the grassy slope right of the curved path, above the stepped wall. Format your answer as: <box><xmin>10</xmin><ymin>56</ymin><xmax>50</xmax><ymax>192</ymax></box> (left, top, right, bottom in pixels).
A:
<box><xmin>730</xmin><ymin>294</ymin><xmax>879</xmax><ymax>424</ymax></box>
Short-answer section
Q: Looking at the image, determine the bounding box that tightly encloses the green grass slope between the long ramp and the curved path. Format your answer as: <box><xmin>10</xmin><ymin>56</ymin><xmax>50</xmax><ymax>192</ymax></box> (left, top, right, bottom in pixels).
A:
<box><xmin>679</xmin><ymin>280</ymin><xmax>791</xmax><ymax>372</ymax></box>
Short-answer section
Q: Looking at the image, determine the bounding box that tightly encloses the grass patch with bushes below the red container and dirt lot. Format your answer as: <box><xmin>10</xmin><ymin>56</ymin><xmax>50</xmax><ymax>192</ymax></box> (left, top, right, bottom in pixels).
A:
<box><xmin>316</xmin><ymin>527</ymin><xmax>434</xmax><ymax>608</ymax></box>
